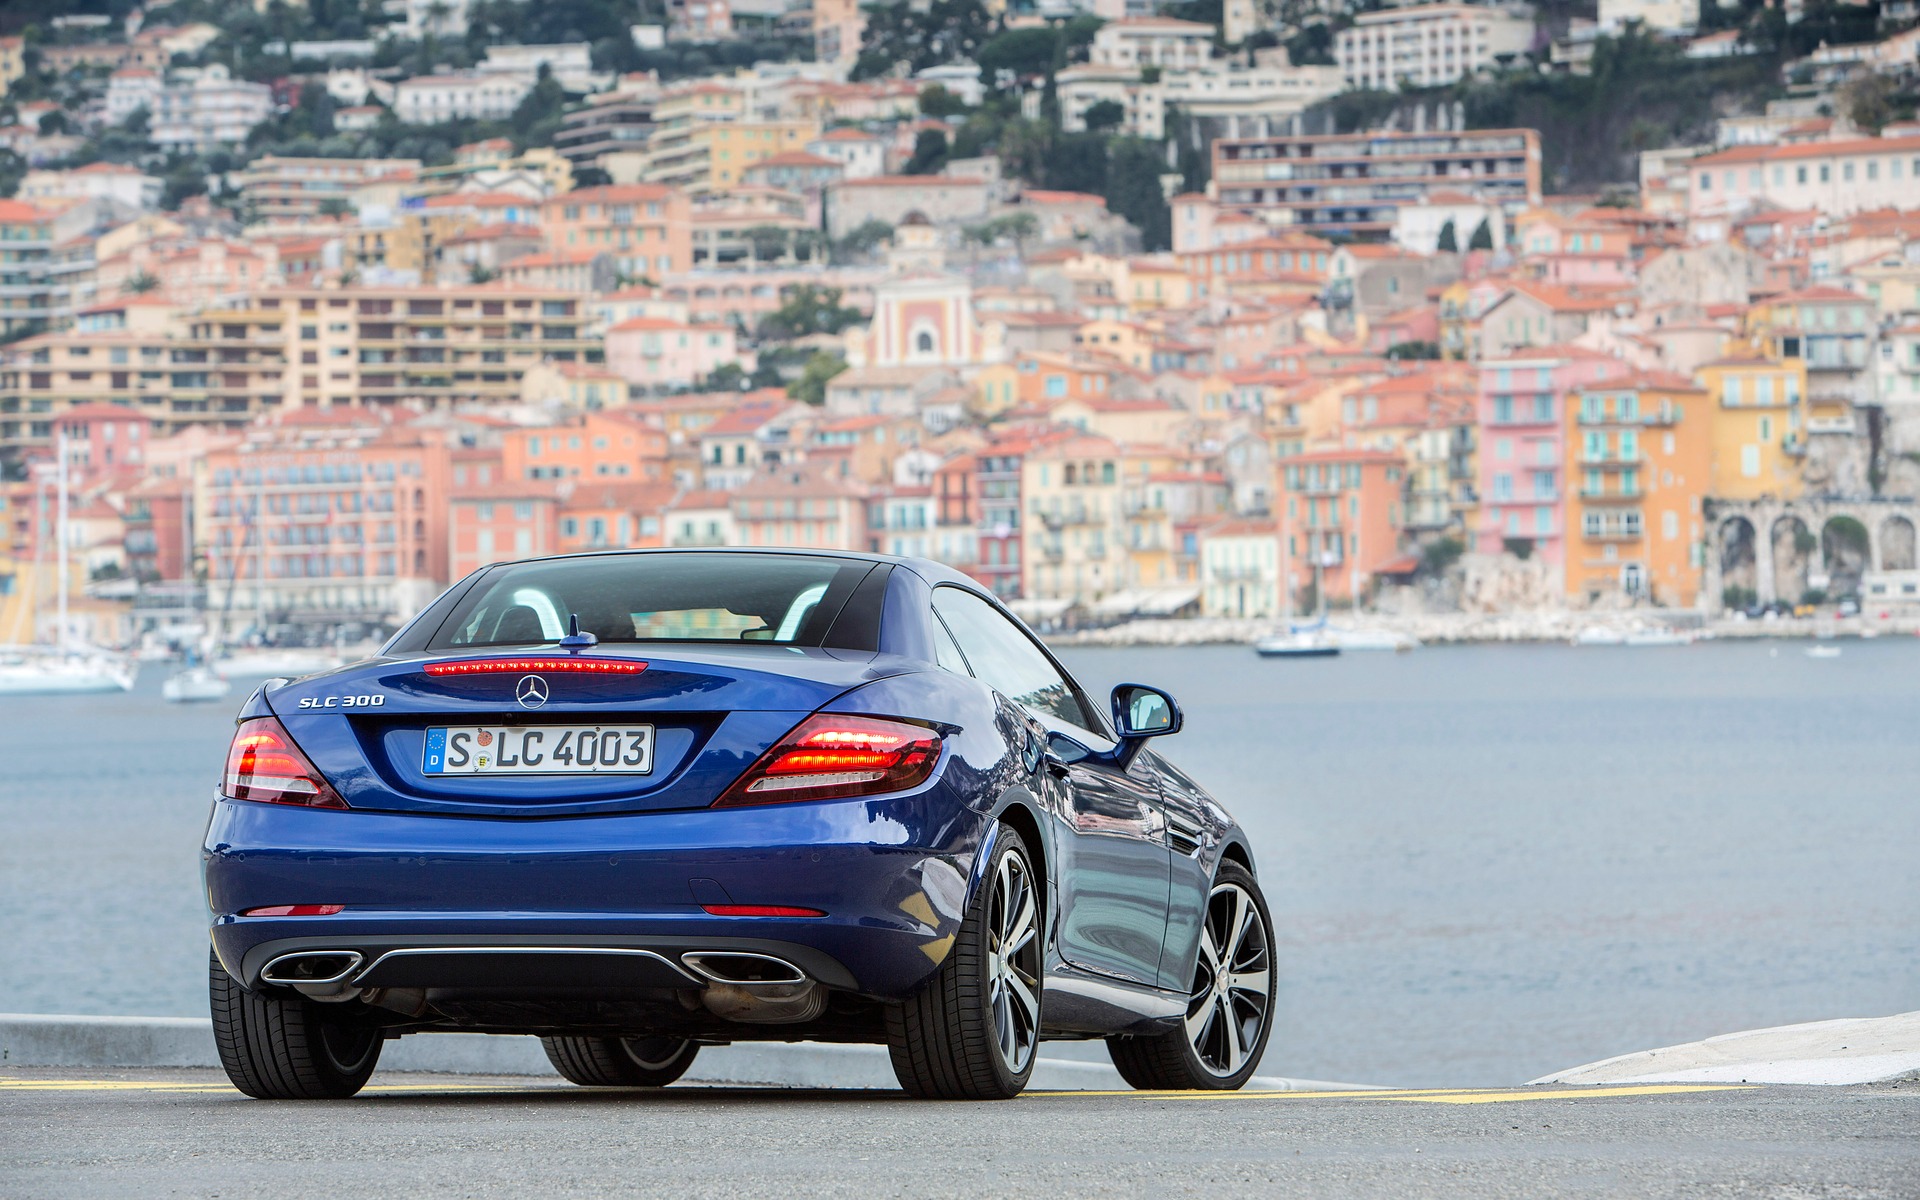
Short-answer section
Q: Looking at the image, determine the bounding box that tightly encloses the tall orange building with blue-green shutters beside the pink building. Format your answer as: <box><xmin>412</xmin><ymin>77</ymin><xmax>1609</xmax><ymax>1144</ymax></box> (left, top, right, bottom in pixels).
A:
<box><xmin>1563</xmin><ymin>372</ymin><xmax>1715</xmax><ymax>607</ymax></box>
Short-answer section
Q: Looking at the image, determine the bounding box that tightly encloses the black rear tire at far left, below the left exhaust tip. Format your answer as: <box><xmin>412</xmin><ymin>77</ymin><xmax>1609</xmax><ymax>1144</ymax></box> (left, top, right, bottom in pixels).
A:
<box><xmin>207</xmin><ymin>950</ymin><xmax>382</xmax><ymax>1100</ymax></box>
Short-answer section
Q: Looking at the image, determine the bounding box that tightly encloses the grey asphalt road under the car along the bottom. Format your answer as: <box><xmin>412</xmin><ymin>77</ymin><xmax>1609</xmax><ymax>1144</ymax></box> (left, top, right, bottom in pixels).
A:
<box><xmin>0</xmin><ymin>1069</ymin><xmax>1920</xmax><ymax>1200</ymax></box>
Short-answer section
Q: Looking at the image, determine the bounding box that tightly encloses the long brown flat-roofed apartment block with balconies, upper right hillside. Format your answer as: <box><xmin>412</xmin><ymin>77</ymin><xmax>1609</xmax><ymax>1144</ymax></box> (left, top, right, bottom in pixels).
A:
<box><xmin>1213</xmin><ymin>129</ymin><xmax>1540</xmax><ymax>238</ymax></box>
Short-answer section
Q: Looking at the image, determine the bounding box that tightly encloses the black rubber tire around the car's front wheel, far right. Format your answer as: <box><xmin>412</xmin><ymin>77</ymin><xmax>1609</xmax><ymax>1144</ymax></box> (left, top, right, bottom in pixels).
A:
<box><xmin>1106</xmin><ymin>862</ymin><xmax>1277</xmax><ymax>1092</ymax></box>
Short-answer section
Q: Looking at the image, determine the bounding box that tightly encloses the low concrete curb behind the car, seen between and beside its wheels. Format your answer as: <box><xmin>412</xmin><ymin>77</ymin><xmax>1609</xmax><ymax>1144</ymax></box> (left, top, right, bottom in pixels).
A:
<box><xmin>0</xmin><ymin>1014</ymin><xmax>1369</xmax><ymax>1091</ymax></box>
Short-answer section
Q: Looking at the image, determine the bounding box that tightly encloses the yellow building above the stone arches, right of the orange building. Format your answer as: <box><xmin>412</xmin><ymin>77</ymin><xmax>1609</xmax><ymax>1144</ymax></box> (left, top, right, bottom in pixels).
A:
<box><xmin>1695</xmin><ymin>359</ymin><xmax>1807</xmax><ymax>499</ymax></box>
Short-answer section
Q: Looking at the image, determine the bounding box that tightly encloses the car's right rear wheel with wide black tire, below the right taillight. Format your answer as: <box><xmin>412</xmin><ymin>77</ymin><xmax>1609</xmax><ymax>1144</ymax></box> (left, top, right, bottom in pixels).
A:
<box><xmin>887</xmin><ymin>824</ymin><xmax>1046</xmax><ymax>1100</ymax></box>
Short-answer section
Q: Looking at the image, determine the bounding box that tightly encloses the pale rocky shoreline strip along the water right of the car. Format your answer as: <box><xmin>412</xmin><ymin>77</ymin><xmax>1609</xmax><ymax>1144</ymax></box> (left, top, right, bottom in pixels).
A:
<box><xmin>1046</xmin><ymin>609</ymin><xmax>1920</xmax><ymax>645</ymax></box>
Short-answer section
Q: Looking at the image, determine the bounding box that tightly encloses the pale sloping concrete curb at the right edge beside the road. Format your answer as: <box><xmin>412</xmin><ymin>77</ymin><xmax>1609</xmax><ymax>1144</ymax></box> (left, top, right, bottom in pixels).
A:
<box><xmin>1534</xmin><ymin>1012</ymin><xmax>1920</xmax><ymax>1087</ymax></box>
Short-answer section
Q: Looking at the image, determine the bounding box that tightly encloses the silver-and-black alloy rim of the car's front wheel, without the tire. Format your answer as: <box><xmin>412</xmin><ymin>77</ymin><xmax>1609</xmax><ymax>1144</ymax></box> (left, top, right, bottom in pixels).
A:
<box><xmin>1187</xmin><ymin>883</ymin><xmax>1273</xmax><ymax>1077</ymax></box>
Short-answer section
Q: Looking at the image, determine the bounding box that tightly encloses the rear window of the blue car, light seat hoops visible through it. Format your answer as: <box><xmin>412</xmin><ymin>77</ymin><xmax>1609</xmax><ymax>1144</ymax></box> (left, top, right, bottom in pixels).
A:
<box><xmin>426</xmin><ymin>553</ymin><xmax>883</xmax><ymax>651</ymax></box>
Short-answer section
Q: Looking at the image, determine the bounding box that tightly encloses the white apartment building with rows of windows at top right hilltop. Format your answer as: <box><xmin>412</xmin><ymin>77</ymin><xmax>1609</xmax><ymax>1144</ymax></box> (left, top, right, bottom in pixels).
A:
<box><xmin>1332</xmin><ymin>4</ymin><xmax>1534</xmax><ymax>92</ymax></box>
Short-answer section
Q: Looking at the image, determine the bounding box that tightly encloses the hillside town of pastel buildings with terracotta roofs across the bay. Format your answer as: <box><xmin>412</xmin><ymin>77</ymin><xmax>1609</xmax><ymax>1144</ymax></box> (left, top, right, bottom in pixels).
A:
<box><xmin>0</xmin><ymin>0</ymin><xmax>1920</xmax><ymax>645</ymax></box>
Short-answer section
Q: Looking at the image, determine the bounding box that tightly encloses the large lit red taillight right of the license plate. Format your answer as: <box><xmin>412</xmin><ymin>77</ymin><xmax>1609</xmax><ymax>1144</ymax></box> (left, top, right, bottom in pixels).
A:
<box><xmin>714</xmin><ymin>712</ymin><xmax>941</xmax><ymax>808</ymax></box>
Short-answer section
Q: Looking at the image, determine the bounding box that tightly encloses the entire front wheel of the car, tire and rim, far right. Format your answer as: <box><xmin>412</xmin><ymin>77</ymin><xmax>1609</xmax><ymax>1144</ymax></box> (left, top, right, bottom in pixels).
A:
<box><xmin>1106</xmin><ymin>862</ymin><xmax>1273</xmax><ymax>1091</ymax></box>
